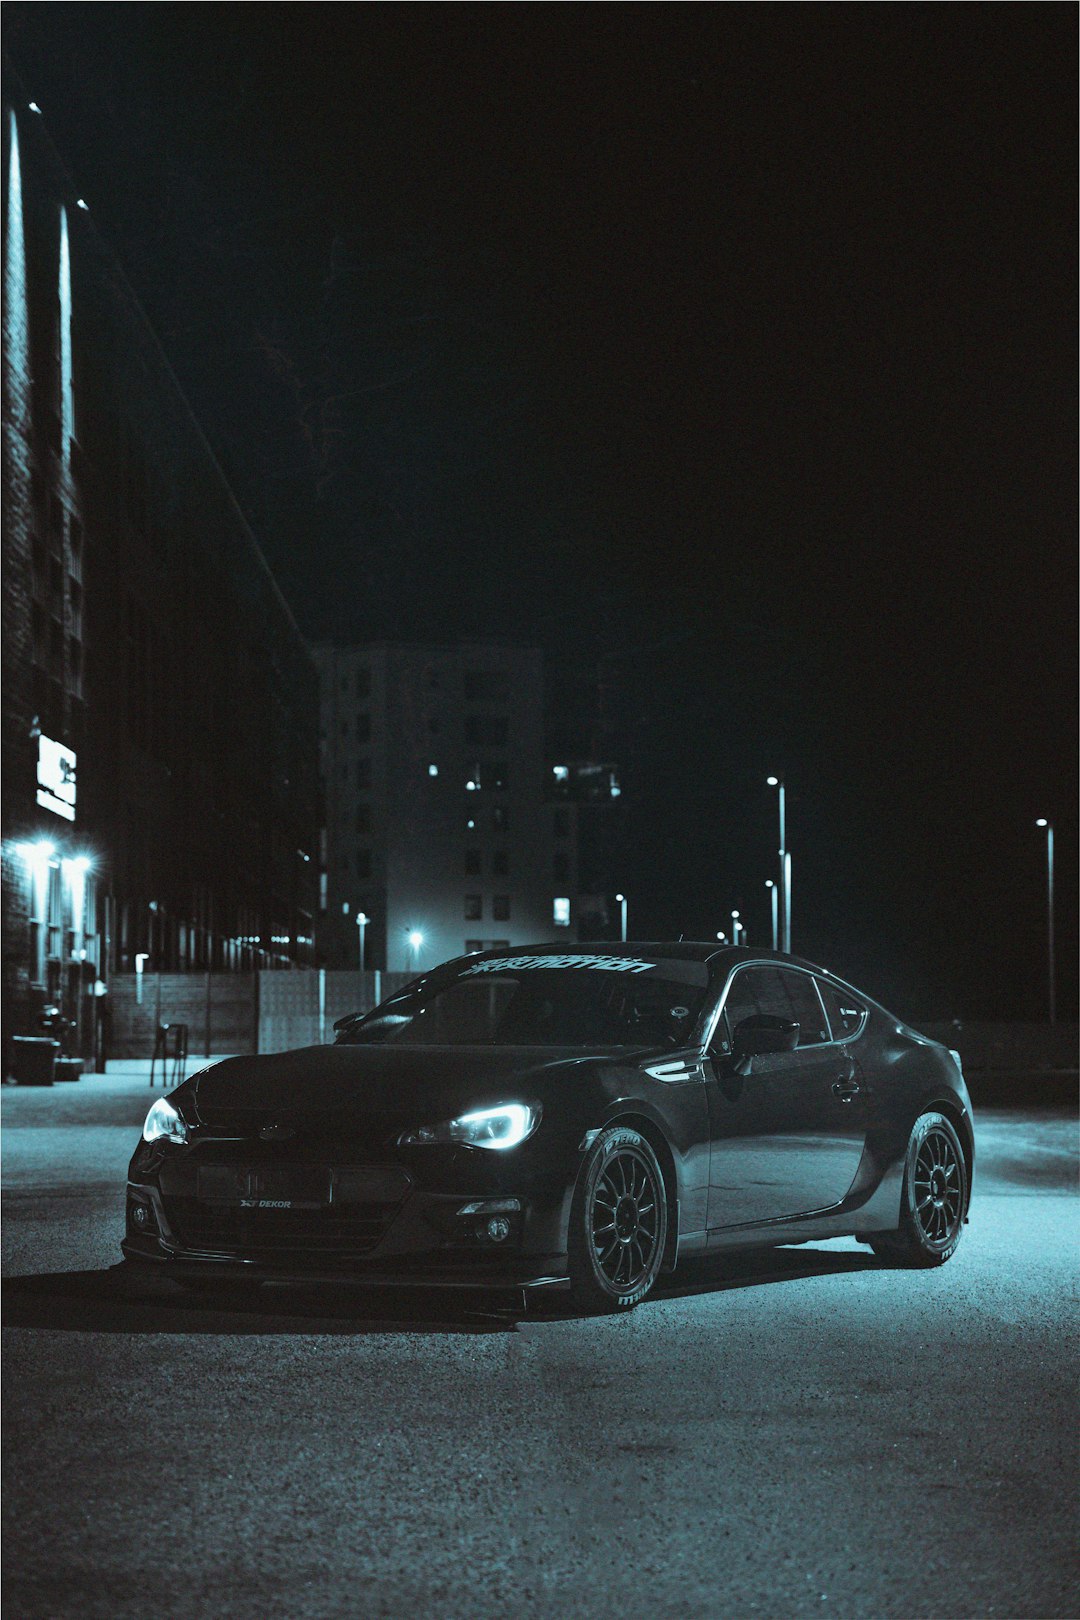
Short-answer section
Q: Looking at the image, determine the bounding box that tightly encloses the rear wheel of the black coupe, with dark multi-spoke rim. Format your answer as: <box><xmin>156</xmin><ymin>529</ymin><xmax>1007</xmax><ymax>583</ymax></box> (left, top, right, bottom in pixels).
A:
<box><xmin>868</xmin><ymin>1113</ymin><xmax>968</xmax><ymax>1267</ymax></box>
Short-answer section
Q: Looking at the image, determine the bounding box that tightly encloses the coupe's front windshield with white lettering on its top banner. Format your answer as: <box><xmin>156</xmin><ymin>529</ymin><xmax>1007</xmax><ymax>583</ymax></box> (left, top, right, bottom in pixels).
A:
<box><xmin>338</xmin><ymin>954</ymin><xmax>708</xmax><ymax>1047</ymax></box>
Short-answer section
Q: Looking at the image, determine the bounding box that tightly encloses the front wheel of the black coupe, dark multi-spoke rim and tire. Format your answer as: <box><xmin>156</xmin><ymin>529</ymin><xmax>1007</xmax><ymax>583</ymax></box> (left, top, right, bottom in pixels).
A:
<box><xmin>567</xmin><ymin>1126</ymin><xmax>667</xmax><ymax>1312</ymax></box>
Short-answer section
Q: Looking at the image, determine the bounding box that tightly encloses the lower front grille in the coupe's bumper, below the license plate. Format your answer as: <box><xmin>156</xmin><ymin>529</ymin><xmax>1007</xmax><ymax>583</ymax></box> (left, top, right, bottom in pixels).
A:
<box><xmin>164</xmin><ymin>1197</ymin><xmax>402</xmax><ymax>1259</ymax></box>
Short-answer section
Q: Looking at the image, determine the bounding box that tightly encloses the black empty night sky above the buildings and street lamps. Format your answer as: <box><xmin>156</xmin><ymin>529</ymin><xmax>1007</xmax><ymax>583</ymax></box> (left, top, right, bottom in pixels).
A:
<box><xmin>5</xmin><ymin>3</ymin><xmax>1077</xmax><ymax>1017</ymax></box>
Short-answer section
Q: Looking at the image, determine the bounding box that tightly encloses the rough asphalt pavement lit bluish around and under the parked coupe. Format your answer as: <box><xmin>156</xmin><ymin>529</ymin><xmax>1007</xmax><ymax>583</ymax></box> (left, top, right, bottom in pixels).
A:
<box><xmin>3</xmin><ymin>1076</ymin><xmax>1080</xmax><ymax>1620</ymax></box>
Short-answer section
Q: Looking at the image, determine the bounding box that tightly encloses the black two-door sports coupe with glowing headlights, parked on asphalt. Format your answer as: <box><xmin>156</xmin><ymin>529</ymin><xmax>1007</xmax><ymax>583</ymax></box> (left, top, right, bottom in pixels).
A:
<box><xmin>123</xmin><ymin>943</ymin><xmax>975</xmax><ymax>1311</ymax></box>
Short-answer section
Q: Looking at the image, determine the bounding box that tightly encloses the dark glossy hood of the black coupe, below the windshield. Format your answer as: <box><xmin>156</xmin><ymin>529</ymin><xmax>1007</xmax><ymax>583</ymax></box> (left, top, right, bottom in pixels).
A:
<box><xmin>194</xmin><ymin>1047</ymin><xmax>641</xmax><ymax>1131</ymax></box>
